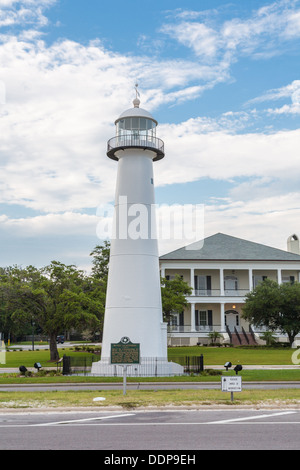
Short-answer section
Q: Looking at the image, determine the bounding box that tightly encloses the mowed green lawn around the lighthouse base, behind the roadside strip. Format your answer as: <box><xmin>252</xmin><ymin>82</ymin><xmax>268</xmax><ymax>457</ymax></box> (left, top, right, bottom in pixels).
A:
<box><xmin>0</xmin><ymin>346</ymin><xmax>300</xmax><ymax>383</ymax></box>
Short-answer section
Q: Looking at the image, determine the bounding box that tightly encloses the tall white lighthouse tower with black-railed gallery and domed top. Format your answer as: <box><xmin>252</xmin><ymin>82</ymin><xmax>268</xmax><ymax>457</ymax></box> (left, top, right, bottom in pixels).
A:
<box><xmin>91</xmin><ymin>90</ymin><xmax>183</xmax><ymax>376</ymax></box>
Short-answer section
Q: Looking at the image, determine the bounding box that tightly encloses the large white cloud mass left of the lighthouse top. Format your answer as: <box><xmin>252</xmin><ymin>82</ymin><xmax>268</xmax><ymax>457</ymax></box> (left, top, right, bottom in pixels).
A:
<box><xmin>0</xmin><ymin>33</ymin><xmax>237</xmax><ymax>212</ymax></box>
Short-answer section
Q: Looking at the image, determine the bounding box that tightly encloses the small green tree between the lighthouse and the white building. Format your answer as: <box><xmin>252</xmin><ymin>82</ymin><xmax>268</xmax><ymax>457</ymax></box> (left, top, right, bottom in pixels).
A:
<box><xmin>161</xmin><ymin>274</ymin><xmax>192</xmax><ymax>321</ymax></box>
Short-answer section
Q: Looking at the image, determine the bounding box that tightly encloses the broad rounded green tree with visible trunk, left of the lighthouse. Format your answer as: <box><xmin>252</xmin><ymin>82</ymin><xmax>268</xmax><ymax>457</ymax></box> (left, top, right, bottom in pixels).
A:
<box><xmin>3</xmin><ymin>261</ymin><xmax>103</xmax><ymax>361</ymax></box>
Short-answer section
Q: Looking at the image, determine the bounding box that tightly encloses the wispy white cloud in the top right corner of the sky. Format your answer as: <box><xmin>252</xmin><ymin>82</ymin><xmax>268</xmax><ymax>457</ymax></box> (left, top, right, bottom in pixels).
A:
<box><xmin>162</xmin><ymin>0</ymin><xmax>300</xmax><ymax>63</ymax></box>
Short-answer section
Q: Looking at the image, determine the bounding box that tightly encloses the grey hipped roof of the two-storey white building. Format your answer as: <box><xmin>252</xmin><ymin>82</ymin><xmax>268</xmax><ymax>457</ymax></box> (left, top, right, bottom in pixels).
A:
<box><xmin>160</xmin><ymin>233</ymin><xmax>300</xmax><ymax>262</ymax></box>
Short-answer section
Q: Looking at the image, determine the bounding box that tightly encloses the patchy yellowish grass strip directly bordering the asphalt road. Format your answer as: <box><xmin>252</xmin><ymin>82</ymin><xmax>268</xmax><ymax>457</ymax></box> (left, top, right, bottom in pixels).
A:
<box><xmin>0</xmin><ymin>388</ymin><xmax>300</xmax><ymax>410</ymax></box>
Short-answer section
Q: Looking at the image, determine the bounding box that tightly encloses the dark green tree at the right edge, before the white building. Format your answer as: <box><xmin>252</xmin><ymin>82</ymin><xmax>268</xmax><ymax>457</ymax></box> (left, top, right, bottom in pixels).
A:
<box><xmin>243</xmin><ymin>279</ymin><xmax>300</xmax><ymax>346</ymax></box>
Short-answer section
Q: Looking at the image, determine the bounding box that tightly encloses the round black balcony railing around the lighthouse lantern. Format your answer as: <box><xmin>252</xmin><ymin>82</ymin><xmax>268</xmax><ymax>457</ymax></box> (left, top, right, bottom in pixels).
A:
<box><xmin>107</xmin><ymin>134</ymin><xmax>165</xmax><ymax>161</ymax></box>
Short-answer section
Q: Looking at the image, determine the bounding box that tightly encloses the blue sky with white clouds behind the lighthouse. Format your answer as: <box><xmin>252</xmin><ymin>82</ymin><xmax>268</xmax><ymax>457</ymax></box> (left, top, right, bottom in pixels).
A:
<box><xmin>0</xmin><ymin>0</ymin><xmax>300</xmax><ymax>271</ymax></box>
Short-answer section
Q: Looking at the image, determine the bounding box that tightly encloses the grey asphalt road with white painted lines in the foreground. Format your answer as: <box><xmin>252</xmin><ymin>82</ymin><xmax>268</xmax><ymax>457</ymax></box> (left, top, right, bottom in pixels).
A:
<box><xmin>0</xmin><ymin>408</ymin><xmax>300</xmax><ymax>452</ymax></box>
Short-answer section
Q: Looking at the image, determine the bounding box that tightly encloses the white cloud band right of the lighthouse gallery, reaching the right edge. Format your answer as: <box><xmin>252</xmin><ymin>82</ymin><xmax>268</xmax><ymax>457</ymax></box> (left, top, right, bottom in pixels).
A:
<box><xmin>155</xmin><ymin>119</ymin><xmax>300</xmax><ymax>185</ymax></box>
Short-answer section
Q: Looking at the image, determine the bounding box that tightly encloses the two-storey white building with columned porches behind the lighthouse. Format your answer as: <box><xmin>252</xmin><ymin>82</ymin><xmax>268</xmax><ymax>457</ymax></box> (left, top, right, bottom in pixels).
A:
<box><xmin>160</xmin><ymin>233</ymin><xmax>300</xmax><ymax>346</ymax></box>
